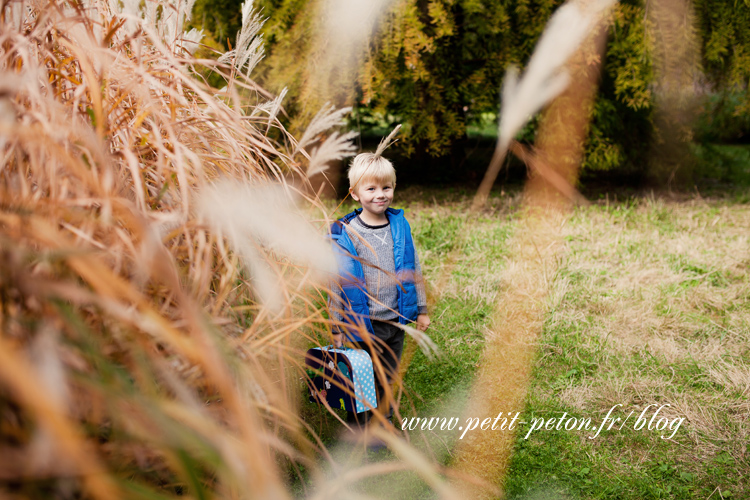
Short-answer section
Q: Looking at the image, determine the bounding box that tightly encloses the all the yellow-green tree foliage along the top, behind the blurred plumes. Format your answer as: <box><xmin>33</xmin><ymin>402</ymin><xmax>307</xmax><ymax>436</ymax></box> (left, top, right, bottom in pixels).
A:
<box><xmin>194</xmin><ymin>0</ymin><xmax>750</xmax><ymax>180</ymax></box>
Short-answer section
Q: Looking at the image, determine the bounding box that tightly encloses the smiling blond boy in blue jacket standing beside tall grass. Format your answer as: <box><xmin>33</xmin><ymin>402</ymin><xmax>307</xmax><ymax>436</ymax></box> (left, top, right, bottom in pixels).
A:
<box><xmin>329</xmin><ymin>153</ymin><xmax>430</xmax><ymax>421</ymax></box>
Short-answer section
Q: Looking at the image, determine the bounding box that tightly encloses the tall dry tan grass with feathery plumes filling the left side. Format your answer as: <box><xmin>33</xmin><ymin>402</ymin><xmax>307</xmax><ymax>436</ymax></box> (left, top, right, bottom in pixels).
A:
<box><xmin>0</xmin><ymin>0</ymin><xmax>390</xmax><ymax>499</ymax></box>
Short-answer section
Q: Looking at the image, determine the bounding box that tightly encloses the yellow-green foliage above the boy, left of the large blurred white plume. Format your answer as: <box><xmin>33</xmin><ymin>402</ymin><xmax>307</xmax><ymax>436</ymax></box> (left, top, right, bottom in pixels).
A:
<box><xmin>361</xmin><ymin>0</ymin><xmax>561</xmax><ymax>156</ymax></box>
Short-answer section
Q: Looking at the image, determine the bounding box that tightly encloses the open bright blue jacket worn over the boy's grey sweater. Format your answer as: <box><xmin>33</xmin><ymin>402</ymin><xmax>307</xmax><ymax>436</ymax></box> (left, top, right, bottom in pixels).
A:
<box><xmin>330</xmin><ymin>208</ymin><xmax>419</xmax><ymax>342</ymax></box>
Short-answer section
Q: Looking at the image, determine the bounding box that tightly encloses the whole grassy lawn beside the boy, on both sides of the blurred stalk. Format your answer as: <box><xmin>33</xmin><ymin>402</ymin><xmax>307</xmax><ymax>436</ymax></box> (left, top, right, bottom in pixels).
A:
<box><xmin>304</xmin><ymin>190</ymin><xmax>750</xmax><ymax>499</ymax></box>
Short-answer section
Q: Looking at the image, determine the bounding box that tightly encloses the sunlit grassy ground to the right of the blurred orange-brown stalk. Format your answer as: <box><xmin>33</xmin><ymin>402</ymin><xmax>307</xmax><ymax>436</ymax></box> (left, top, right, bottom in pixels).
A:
<box><xmin>506</xmin><ymin>198</ymin><xmax>750</xmax><ymax>499</ymax></box>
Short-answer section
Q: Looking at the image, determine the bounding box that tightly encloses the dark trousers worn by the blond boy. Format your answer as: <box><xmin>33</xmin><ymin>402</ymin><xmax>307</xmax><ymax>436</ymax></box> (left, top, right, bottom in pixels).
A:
<box><xmin>347</xmin><ymin>318</ymin><xmax>404</xmax><ymax>423</ymax></box>
